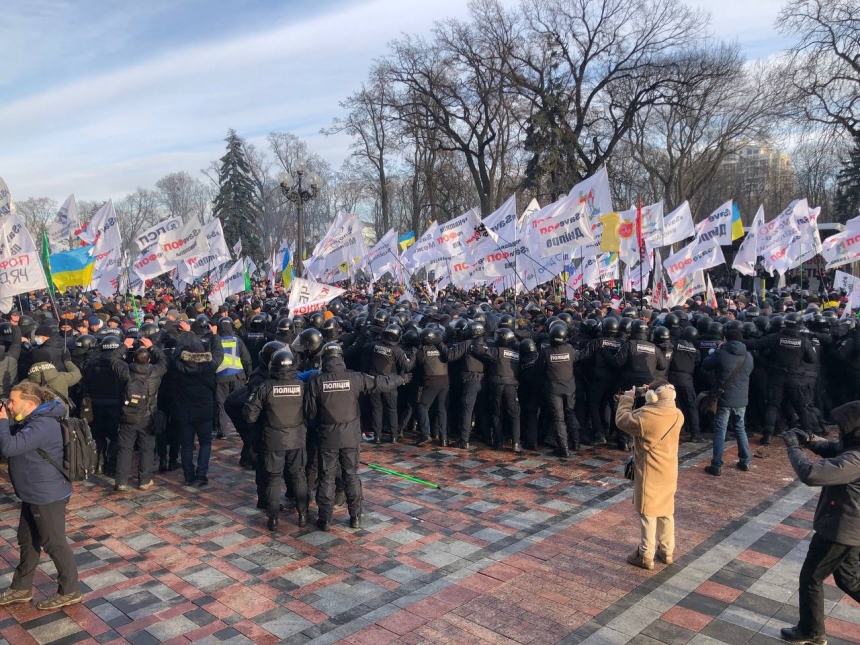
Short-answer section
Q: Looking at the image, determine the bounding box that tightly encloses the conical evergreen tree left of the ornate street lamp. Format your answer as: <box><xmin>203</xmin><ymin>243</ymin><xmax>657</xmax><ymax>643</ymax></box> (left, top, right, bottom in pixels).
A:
<box><xmin>213</xmin><ymin>129</ymin><xmax>263</xmax><ymax>262</ymax></box>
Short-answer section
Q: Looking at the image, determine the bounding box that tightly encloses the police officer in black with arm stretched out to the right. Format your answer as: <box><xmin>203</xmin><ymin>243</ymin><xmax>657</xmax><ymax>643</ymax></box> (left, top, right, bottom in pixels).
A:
<box><xmin>305</xmin><ymin>343</ymin><xmax>412</xmax><ymax>531</ymax></box>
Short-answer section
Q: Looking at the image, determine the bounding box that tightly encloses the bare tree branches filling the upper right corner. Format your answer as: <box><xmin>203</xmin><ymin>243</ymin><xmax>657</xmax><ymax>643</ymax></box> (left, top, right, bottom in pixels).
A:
<box><xmin>776</xmin><ymin>0</ymin><xmax>860</xmax><ymax>137</ymax></box>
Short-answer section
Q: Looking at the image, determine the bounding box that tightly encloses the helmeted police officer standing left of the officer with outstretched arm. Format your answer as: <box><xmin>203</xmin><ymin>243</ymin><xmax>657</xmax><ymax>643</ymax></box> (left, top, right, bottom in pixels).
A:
<box><xmin>242</xmin><ymin>349</ymin><xmax>308</xmax><ymax>531</ymax></box>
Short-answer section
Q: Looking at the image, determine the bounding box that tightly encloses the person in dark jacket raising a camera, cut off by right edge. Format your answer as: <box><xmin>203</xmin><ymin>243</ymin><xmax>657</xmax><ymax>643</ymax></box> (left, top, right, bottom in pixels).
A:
<box><xmin>782</xmin><ymin>401</ymin><xmax>860</xmax><ymax>645</ymax></box>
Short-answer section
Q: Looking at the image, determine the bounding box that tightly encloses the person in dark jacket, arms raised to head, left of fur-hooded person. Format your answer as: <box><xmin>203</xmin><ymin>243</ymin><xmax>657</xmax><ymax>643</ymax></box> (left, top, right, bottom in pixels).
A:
<box><xmin>110</xmin><ymin>338</ymin><xmax>167</xmax><ymax>493</ymax></box>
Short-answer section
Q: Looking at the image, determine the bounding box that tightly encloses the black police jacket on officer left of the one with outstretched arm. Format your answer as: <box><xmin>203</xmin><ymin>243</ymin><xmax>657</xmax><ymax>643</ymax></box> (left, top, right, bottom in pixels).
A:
<box><xmin>242</xmin><ymin>370</ymin><xmax>307</xmax><ymax>450</ymax></box>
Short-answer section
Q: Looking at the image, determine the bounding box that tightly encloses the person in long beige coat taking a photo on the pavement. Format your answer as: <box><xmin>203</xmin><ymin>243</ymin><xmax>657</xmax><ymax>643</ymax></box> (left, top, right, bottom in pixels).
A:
<box><xmin>615</xmin><ymin>380</ymin><xmax>684</xmax><ymax>569</ymax></box>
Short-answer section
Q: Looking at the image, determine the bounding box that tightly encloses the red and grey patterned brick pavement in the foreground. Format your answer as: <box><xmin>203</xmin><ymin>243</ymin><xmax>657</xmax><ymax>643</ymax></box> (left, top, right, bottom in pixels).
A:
<box><xmin>0</xmin><ymin>432</ymin><xmax>860</xmax><ymax>645</ymax></box>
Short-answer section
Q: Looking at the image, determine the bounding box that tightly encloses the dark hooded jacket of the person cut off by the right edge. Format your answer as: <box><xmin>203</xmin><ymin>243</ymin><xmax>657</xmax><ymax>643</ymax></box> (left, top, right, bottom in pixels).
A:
<box><xmin>788</xmin><ymin>401</ymin><xmax>860</xmax><ymax>546</ymax></box>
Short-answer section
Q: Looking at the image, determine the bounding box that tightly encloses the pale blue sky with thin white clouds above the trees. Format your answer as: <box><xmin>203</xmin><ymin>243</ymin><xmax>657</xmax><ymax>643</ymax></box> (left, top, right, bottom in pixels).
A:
<box><xmin>0</xmin><ymin>0</ymin><xmax>785</xmax><ymax>202</ymax></box>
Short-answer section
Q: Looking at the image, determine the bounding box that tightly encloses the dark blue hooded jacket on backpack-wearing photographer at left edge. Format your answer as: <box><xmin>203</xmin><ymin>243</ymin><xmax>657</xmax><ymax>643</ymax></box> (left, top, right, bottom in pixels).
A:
<box><xmin>0</xmin><ymin>401</ymin><xmax>72</xmax><ymax>505</ymax></box>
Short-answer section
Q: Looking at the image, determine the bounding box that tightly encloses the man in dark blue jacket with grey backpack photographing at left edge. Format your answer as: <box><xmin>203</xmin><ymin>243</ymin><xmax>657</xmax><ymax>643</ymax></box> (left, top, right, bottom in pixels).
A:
<box><xmin>0</xmin><ymin>382</ymin><xmax>82</xmax><ymax>609</ymax></box>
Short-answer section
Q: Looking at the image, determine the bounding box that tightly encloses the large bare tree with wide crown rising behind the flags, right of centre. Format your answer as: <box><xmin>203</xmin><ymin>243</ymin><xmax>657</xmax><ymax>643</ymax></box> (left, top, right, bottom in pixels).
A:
<box><xmin>508</xmin><ymin>0</ymin><xmax>708</xmax><ymax>199</ymax></box>
